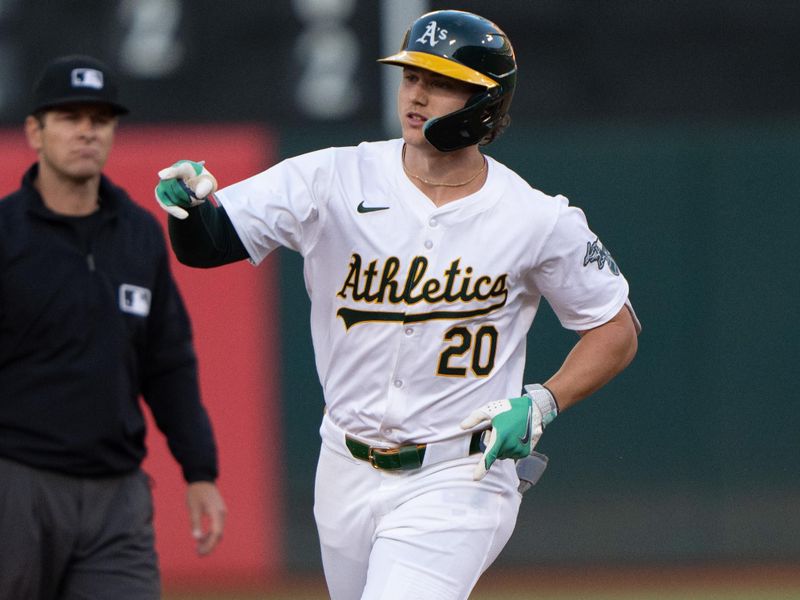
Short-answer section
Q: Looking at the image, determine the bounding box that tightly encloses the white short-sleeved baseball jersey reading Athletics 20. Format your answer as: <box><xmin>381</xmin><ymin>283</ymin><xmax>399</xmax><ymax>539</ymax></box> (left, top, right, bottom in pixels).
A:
<box><xmin>217</xmin><ymin>140</ymin><xmax>628</xmax><ymax>445</ymax></box>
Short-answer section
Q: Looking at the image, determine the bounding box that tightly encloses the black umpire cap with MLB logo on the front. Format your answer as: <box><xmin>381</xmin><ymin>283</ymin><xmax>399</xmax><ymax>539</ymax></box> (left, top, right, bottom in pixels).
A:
<box><xmin>30</xmin><ymin>54</ymin><xmax>128</xmax><ymax>115</ymax></box>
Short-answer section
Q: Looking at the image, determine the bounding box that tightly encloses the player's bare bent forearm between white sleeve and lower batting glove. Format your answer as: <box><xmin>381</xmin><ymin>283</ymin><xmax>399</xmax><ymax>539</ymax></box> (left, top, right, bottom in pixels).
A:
<box><xmin>545</xmin><ymin>308</ymin><xmax>638</xmax><ymax>411</ymax></box>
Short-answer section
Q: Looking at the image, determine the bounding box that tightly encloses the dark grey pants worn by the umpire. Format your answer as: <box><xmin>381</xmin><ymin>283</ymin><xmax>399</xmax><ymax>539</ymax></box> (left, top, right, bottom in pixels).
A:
<box><xmin>0</xmin><ymin>458</ymin><xmax>161</xmax><ymax>600</ymax></box>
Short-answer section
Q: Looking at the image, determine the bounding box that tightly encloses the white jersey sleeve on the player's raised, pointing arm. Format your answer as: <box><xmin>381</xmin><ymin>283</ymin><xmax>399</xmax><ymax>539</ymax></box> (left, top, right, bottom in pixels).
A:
<box><xmin>216</xmin><ymin>150</ymin><xmax>334</xmax><ymax>264</ymax></box>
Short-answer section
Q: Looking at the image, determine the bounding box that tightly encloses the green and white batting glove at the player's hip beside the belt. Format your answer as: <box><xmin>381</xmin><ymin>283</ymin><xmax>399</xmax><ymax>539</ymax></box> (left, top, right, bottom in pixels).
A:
<box><xmin>461</xmin><ymin>383</ymin><xmax>558</xmax><ymax>481</ymax></box>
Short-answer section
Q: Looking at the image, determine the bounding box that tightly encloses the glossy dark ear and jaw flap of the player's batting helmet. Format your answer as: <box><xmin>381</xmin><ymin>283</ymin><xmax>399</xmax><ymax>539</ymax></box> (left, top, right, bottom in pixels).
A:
<box><xmin>422</xmin><ymin>87</ymin><xmax>503</xmax><ymax>152</ymax></box>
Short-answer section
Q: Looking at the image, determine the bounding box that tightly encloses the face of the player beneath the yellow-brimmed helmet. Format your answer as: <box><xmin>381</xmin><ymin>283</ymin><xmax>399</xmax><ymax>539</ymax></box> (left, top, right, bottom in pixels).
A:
<box><xmin>397</xmin><ymin>67</ymin><xmax>483</xmax><ymax>149</ymax></box>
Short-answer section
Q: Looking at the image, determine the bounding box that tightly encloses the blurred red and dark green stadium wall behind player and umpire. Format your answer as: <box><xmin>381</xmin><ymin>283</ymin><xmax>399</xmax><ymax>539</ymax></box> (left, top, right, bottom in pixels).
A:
<box><xmin>0</xmin><ymin>0</ymin><xmax>800</xmax><ymax>589</ymax></box>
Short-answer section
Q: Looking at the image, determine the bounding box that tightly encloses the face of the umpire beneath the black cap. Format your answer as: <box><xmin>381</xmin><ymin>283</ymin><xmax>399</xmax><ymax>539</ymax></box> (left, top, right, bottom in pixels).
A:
<box><xmin>25</xmin><ymin>104</ymin><xmax>117</xmax><ymax>182</ymax></box>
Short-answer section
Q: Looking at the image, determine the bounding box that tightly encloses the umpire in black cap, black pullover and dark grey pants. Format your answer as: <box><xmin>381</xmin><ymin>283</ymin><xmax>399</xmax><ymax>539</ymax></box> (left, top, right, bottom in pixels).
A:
<box><xmin>0</xmin><ymin>56</ymin><xmax>225</xmax><ymax>600</ymax></box>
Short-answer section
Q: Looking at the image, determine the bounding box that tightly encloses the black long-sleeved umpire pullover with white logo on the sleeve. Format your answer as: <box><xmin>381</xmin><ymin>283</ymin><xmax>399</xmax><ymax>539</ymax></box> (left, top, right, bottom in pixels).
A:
<box><xmin>0</xmin><ymin>165</ymin><xmax>217</xmax><ymax>482</ymax></box>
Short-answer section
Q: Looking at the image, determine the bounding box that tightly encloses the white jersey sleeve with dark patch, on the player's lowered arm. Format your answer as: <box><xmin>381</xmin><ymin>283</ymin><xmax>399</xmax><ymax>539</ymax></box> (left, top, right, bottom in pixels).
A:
<box><xmin>534</xmin><ymin>196</ymin><xmax>629</xmax><ymax>331</ymax></box>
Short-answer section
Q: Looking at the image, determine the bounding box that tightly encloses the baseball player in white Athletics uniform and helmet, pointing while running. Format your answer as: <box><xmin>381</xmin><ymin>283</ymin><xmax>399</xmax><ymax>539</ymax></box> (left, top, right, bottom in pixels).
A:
<box><xmin>156</xmin><ymin>10</ymin><xmax>639</xmax><ymax>600</ymax></box>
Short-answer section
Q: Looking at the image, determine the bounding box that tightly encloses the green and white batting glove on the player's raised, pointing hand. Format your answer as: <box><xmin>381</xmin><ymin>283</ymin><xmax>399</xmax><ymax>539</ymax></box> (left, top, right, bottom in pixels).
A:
<box><xmin>155</xmin><ymin>160</ymin><xmax>217</xmax><ymax>219</ymax></box>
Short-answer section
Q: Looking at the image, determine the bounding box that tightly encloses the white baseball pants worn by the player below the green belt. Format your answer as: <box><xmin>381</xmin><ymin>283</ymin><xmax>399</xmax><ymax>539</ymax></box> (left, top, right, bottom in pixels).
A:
<box><xmin>314</xmin><ymin>417</ymin><xmax>522</xmax><ymax>600</ymax></box>
